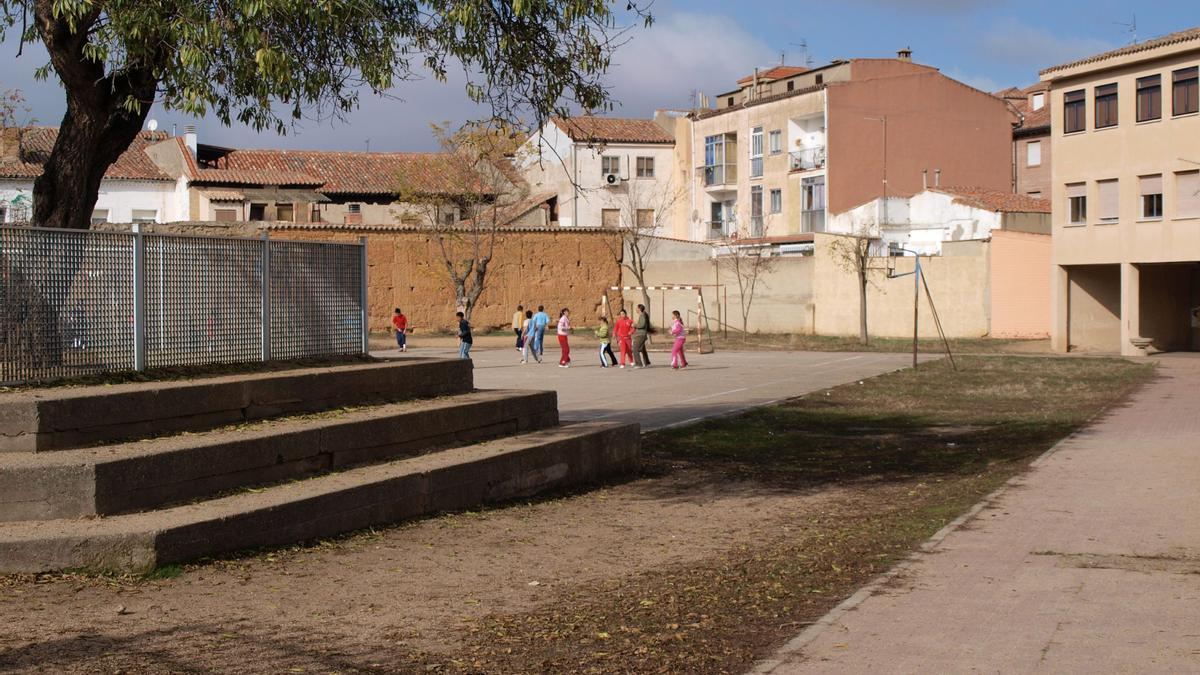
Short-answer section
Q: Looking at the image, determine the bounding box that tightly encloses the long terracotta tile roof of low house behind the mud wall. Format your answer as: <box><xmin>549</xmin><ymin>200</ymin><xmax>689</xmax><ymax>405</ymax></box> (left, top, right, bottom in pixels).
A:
<box><xmin>194</xmin><ymin>150</ymin><xmax>481</xmax><ymax>195</ymax></box>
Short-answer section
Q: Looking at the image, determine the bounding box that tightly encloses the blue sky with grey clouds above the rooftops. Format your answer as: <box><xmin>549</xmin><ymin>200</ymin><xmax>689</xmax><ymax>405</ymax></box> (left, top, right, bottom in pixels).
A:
<box><xmin>0</xmin><ymin>0</ymin><xmax>1200</xmax><ymax>151</ymax></box>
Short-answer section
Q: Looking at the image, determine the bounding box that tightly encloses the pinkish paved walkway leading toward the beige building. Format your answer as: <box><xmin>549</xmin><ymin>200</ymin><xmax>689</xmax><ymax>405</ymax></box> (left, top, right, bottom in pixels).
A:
<box><xmin>757</xmin><ymin>354</ymin><xmax>1200</xmax><ymax>674</ymax></box>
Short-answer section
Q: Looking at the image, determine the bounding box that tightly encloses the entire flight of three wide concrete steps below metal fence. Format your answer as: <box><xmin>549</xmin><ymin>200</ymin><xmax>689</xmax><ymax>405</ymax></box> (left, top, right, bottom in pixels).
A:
<box><xmin>0</xmin><ymin>359</ymin><xmax>640</xmax><ymax>573</ymax></box>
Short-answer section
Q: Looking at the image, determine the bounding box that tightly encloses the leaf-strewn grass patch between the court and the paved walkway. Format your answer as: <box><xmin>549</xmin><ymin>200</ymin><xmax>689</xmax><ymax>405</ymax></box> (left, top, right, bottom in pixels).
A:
<box><xmin>406</xmin><ymin>357</ymin><xmax>1153</xmax><ymax>673</ymax></box>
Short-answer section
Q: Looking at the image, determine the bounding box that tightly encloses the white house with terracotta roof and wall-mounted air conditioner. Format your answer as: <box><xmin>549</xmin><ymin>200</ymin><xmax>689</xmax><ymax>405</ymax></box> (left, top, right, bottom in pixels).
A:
<box><xmin>515</xmin><ymin>115</ymin><xmax>685</xmax><ymax>229</ymax></box>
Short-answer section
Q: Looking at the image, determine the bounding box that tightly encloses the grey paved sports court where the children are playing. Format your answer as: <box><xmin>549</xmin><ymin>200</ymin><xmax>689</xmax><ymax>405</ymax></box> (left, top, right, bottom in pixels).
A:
<box><xmin>374</xmin><ymin>342</ymin><xmax>934</xmax><ymax>431</ymax></box>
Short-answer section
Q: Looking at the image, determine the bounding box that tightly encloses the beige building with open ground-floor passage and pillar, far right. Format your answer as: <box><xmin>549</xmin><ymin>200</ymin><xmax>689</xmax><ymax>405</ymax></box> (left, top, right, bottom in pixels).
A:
<box><xmin>1042</xmin><ymin>28</ymin><xmax>1200</xmax><ymax>356</ymax></box>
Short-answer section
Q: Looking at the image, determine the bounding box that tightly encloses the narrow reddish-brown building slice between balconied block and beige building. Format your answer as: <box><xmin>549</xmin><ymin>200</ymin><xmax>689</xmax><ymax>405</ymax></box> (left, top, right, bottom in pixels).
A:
<box><xmin>996</xmin><ymin>82</ymin><xmax>1051</xmax><ymax>199</ymax></box>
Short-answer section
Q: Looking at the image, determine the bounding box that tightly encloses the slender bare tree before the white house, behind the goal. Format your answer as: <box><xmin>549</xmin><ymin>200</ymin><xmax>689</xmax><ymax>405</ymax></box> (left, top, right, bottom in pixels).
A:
<box><xmin>600</xmin><ymin>169</ymin><xmax>684</xmax><ymax>315</ymax></box>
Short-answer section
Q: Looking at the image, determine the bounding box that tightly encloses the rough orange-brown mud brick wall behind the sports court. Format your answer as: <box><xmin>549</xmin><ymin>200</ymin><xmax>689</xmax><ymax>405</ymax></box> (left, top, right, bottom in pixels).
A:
<box><xmin>270</xmin><ymin>226</ymin><xmax>620</xmax><ymax>331</ymax></box>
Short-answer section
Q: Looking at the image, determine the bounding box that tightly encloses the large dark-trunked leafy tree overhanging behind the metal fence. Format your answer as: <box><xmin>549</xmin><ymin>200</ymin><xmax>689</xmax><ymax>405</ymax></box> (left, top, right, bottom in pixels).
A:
<box><xmin>0</xmin><ymin>0</ymin><xmax>652</xmax><ymax>228</ymax></box>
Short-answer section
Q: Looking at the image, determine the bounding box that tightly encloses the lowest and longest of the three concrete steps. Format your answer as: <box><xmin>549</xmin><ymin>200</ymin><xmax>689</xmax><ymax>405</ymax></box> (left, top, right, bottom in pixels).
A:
<box><xmin>0</xmin><ymin>423</ymin><xmax>640</xmax><ymax>573</ymax></box>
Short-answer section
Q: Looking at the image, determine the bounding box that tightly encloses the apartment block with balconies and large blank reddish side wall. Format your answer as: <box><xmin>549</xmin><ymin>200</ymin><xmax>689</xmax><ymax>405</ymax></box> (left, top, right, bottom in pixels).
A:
<box><xmin>673</xmin><ymin>50</ymin><xmax>1013</xmax><ymax>240</ymax></box>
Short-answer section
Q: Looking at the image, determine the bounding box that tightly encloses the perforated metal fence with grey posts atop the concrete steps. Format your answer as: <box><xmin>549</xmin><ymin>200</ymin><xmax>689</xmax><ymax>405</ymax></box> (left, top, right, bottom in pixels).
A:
<box><xmin>0</xmin><ymin>227</ymin><xmax>367</xmax><ymax>384</ymax></box>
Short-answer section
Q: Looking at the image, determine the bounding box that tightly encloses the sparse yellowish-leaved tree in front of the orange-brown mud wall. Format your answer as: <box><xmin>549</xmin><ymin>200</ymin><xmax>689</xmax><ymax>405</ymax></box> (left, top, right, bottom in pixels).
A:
<box><xmin>398</xmin><ymin>124</ymin><xmax>528</xmax><ymax>321</ymax></box>
